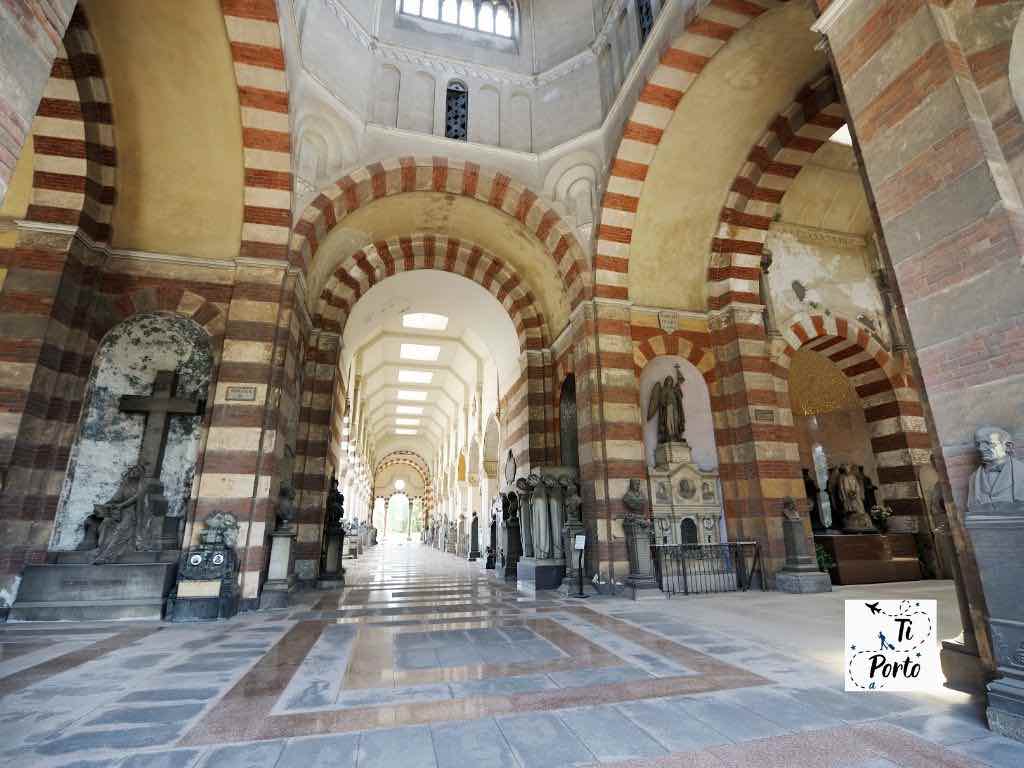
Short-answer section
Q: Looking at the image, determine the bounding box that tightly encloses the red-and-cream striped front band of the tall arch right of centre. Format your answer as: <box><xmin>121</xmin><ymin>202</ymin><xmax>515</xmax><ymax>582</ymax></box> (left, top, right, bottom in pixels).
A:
<box><xmin>594</xmin><ymin>0</ymin><xmax>780</xmax><ymax>299</ymax></box>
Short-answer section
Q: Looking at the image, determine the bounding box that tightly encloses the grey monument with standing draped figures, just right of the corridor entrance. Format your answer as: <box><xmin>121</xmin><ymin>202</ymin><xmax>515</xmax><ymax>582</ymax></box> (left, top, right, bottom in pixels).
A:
<box><xmin>514</xmin><ymin>467</ymin><xmax>579</xmax><ymax>593</ymax></box>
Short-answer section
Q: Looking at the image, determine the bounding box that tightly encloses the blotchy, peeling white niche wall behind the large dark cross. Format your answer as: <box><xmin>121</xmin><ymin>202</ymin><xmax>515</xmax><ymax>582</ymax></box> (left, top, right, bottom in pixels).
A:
<box><xmin>50</xmin><ymin>312</ymin><xmax>214</xmax><ymax>550</ymax></box>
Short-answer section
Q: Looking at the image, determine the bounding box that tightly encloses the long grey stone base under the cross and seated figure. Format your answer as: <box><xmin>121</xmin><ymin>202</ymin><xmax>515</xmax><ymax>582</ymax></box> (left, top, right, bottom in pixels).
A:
<box><xmin>9</xmin><ymin>553</ymin><xmax>178</xmax><ymax>622</ymax></box>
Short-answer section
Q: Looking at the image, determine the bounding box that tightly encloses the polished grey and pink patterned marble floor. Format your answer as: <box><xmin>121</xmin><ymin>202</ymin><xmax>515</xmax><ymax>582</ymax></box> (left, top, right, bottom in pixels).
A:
<box><xmin>0</xmin><ymin>544</ymin><xmax>1024</xmax><ymax>768</ymax></box>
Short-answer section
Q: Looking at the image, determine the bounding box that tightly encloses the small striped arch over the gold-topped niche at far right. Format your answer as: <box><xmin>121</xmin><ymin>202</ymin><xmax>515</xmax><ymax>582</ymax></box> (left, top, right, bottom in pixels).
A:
<box><xmin>773</xmin><ymin>313</ymin><xmax>931</xmax><ymax>515</ymax></box>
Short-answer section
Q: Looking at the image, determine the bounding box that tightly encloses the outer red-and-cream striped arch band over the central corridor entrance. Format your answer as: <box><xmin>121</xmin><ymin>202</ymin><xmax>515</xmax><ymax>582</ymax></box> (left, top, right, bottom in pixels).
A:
<box><xmin>291</xmin><ymin>157</ymin><xmax>590</xmax><ymax>307</ymax></box>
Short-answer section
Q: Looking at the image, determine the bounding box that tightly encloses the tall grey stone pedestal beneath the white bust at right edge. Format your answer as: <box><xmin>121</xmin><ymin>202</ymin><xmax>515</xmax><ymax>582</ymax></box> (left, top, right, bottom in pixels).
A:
<box><xmin>965</xmin><ymin>504</ymin><xmax>1024</xmax><ymax>741</ymax></box>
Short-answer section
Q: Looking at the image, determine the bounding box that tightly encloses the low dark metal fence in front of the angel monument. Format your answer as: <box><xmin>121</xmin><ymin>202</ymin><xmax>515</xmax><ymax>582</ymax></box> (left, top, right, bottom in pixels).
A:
<box><xmin>654</xmin><ymin>542</ymin><xmax>765</xmax><ymax>597</ymax></box>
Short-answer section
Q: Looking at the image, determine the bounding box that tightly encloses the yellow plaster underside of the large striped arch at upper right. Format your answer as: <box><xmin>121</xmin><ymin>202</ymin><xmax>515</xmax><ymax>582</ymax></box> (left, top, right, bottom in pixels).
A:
<box><xmin>630</xmin><ymin>2</ymin><xmax>827</xmax><ymax>310</ymax></box>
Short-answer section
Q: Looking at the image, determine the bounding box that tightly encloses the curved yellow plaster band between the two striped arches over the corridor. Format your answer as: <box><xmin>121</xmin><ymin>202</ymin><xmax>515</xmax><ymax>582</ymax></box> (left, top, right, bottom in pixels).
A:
<box><xmin>307</xmin><ymin>193</ymin><xmax>569</xmax><ymax>338</ymax></box>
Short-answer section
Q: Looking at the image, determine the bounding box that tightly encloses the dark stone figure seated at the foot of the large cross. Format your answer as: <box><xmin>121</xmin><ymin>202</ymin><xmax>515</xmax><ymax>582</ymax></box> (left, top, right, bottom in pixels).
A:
<box><xmin>82</xmin><ymin>464</ymin><xmax>160</xmax><ymax>565</ymax></box>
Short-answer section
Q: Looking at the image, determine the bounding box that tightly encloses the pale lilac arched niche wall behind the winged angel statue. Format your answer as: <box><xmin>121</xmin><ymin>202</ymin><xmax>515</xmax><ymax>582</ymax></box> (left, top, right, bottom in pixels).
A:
<box><xmin>640</xmin><ymin>354</ymin><xmax>718</xmax><ymax>469</ymax></box>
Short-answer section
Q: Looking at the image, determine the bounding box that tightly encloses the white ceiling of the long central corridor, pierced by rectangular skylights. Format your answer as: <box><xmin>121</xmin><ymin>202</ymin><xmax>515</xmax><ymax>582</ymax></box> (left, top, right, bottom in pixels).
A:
<box><xmin>342</xmin><ymin>269</ymin><xmax>520</xmax><ymax>458</ymax></box>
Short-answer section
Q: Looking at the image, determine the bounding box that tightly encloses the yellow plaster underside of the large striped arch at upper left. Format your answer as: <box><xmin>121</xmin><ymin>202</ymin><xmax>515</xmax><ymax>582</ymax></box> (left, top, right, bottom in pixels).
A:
<box><xmin>83</xmin><ymin>0</ymin><xmax>244</xmax><ymax>259</ymax></box>
